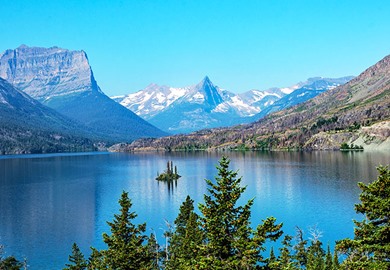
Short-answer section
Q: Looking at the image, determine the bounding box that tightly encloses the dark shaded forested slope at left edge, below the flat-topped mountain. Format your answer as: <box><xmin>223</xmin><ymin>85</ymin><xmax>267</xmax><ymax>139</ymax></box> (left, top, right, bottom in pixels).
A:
<box><xmin>0</xmin><ymin>78</ymin><xmax>97</xmax><ymax>154</ymax></box>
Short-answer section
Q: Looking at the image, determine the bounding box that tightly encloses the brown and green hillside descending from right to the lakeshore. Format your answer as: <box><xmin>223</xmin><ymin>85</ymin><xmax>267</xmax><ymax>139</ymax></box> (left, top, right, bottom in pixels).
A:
<box><xmin>112</xmin><ymin>55</ymin><xmax>390</xmax><ymax>151</ymax></box>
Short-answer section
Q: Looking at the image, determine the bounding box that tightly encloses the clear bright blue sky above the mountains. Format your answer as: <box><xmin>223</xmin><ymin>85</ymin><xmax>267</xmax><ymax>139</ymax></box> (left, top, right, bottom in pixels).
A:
<box><xmin>0</xmin><ymin>0</ymin><xmax>390</xmax><ymax>95</ymax></box>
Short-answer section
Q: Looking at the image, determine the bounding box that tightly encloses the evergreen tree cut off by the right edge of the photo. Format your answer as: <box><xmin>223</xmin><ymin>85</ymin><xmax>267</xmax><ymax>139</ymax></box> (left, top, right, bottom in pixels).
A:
<box><xmin>336</xmin><ymin>166</ymin><xmax>390</xmax><ymax>269</ymax></box>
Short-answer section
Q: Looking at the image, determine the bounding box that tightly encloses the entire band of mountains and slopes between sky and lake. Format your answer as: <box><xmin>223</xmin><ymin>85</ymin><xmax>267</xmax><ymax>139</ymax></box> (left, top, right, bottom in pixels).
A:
<box><xmin>0</xmin><ymin>45</ymin><xmax>390</xmax><ymax>154</ymax></box>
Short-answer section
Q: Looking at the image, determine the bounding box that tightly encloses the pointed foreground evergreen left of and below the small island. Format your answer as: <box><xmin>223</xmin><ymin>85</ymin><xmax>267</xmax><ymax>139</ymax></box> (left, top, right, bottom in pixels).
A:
<box><xmin>102</xmin><ymin>192</ymin><xmax>154</xmax><ymax>270</ymax></box>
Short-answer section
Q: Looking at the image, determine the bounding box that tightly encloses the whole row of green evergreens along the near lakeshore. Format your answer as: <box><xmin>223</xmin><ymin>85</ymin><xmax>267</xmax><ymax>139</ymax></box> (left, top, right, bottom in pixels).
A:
<box><xmin>0</xmin><ymin>157</ymin><xmax>390</xmax><ymax>270</ymax></box>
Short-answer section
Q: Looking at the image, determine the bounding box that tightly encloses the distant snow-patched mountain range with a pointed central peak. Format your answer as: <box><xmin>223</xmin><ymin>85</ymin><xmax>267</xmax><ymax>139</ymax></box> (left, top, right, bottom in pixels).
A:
<box><xmin>112</xmin><ymin>76</ymin><xmax>353</xmax><ymax>133</ymax></box>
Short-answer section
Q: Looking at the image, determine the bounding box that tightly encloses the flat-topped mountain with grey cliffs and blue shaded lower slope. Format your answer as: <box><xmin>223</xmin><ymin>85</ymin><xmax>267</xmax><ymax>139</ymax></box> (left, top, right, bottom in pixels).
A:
<box><xmin>0</xmin><ymin>45</ymin><xmax>166</xmax><ymax>142</ymax></box>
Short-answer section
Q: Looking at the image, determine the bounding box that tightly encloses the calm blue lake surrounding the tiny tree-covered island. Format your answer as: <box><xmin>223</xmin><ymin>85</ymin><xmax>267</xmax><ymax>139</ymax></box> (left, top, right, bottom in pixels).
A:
<box><xmin>0</xmin><ymin>152</ymin><xmax>390</xmax><ymax>270</ymax></box>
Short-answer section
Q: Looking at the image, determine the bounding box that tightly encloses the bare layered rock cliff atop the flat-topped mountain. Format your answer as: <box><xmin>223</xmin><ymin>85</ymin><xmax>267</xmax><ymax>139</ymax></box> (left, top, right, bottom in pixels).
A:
<box><xmin>0</xmin><ymin>45</ymin><xmax>100</xmax><ymax>102</ymax></box>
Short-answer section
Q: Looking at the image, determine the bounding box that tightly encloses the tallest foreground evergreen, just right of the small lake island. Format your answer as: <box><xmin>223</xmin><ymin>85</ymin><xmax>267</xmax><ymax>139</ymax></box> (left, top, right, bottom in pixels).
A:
<box><xmin>199</xmin><ymin>157</ymin><xmax>282</xmax><ymax>269</ymax></box>
